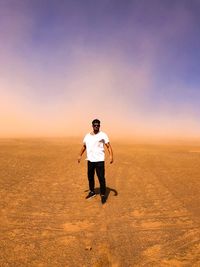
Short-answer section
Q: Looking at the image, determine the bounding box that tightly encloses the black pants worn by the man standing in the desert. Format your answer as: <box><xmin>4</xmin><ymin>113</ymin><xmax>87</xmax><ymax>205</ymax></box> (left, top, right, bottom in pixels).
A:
<box><xmin>88</xmin><ymin>161</ymin><xmax>106</xmax><ymax>195</ymax></box>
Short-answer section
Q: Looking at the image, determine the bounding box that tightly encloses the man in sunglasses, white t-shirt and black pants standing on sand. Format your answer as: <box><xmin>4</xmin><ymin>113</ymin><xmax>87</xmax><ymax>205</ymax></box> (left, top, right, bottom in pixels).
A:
<box><xmin>78</xmin><ymin>119</ymin><xmax>113</xmax><ymax>204</ymax></box>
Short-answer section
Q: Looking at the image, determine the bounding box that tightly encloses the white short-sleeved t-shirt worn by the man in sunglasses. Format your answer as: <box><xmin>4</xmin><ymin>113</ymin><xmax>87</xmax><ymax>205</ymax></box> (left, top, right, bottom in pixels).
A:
<box><xmin>83</xmin><ymin>131</ymin><xmax>109</xmax><ymax>162</ymax></box>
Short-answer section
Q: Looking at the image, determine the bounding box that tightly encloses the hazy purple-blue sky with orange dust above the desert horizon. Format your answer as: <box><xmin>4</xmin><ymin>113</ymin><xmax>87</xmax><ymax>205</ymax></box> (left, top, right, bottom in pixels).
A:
<box><xmin>0</xmin><ymin>0</ymin><xmax>200</xmax><ymax>139</ymax></box>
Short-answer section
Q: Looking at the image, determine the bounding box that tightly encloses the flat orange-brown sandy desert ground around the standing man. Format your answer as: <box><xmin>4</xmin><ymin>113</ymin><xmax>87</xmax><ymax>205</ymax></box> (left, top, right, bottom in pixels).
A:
<box><xmin>0</xmin><ymin>138</ymin><xmax>200</xmax><ymax>267</ymax></box>
